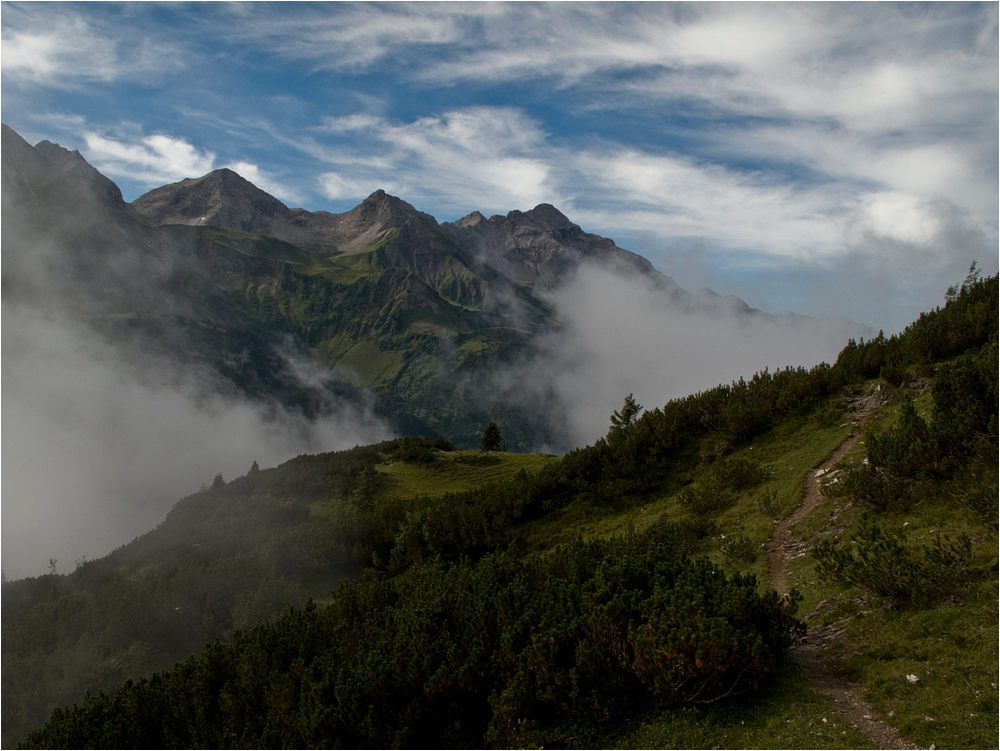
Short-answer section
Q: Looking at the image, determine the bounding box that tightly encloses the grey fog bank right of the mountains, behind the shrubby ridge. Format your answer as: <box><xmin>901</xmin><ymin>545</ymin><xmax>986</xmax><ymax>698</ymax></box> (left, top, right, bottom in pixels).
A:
<box><xmin>500</xmin><ymin>265</ymin><xmax>872</xmax><ymax>448</ymax></box>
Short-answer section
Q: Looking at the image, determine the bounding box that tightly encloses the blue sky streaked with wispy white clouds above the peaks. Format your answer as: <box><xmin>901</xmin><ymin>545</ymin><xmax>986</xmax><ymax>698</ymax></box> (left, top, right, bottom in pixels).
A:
<box><xmin>0</xmin><ymin>2</ymin><xmax>998</xmax><ymax>332</ymax></box>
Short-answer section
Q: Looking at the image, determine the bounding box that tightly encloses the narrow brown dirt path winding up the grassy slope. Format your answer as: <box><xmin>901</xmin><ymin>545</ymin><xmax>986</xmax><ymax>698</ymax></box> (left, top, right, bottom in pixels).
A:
<box><xmin>765</xmin><ymin>430</ymin><xmax>917</xmax><ymax>749</ymax></box>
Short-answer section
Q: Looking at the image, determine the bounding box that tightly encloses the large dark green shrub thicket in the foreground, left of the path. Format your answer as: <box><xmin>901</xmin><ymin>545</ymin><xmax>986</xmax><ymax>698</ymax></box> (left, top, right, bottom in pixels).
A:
<box><xmin>25</xmin><ymin>536</ymin><xmax>802</xmax><ymax>748</ymax></box>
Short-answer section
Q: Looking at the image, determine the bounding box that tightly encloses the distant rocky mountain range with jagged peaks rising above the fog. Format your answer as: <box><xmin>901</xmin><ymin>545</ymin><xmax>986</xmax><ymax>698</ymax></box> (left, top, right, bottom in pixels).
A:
<box><xmin>2</xmin><ymin>126</ymin><xmax>764</xmax><ymax>448</ymax></box>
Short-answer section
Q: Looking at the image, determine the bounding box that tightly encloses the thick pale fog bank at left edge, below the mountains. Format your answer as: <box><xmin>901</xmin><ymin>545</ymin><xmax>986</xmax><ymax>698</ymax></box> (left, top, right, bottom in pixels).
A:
<box><xmin>2</xmin><ymin>304</ymin><xmax>390</xmax><ymax>579</ymax></box>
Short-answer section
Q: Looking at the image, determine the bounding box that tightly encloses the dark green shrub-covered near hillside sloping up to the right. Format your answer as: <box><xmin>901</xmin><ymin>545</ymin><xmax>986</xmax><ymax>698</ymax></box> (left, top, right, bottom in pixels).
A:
<box><xmin>4</xmin><ymin>278</ymin><xmax>998</xmax><ymax>748</ymax></box>
